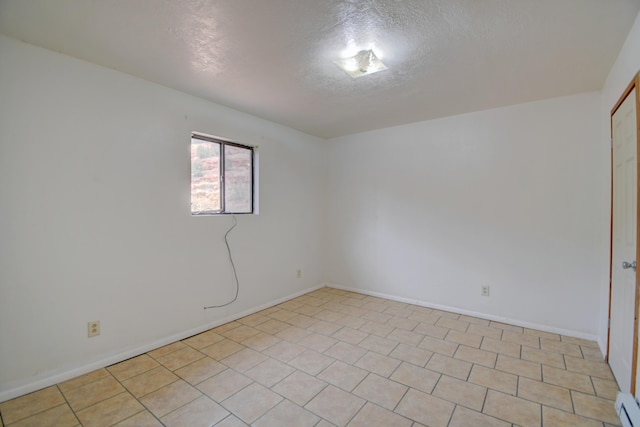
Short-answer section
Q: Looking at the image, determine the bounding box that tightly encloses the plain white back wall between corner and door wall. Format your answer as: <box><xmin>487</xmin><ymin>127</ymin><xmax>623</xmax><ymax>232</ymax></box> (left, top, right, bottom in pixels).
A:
<box><xmin>328</xmin><ymin>92</ymin><xmax>609</xmax><ymax>338</ymax></box>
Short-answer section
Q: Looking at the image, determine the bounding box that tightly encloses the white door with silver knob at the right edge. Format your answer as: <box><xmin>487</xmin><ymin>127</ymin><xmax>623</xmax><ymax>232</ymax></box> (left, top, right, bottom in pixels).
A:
<box><xmin>609</xmin><ymin>89</ymin><xmax>638</xmax><ymax>392</ymax></box>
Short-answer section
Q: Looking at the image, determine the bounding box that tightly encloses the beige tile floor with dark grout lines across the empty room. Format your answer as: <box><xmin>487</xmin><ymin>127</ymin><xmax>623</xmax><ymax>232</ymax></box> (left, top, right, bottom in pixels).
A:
<box><xmin>0</xmin><ymin>288</ymin><xmax>619</xmax><ymax>427</ymax></box>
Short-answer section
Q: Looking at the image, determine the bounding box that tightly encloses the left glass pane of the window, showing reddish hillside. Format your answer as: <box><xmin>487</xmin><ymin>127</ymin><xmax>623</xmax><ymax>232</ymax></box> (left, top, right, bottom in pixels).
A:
<box><xmin>191</xmin><ymin>138</ymin><xmax>221</xmax><ymax>213</ymax></box>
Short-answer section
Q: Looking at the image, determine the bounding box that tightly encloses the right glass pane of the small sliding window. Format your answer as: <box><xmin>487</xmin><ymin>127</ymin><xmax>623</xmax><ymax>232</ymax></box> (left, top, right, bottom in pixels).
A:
<box><xmin>224</xmin><ymin>145</ymin><xmax>253</xmax><ymax>213</ymax></box>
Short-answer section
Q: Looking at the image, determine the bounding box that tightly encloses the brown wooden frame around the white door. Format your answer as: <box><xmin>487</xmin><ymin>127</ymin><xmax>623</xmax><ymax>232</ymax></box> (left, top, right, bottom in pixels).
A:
<box><xmin>606</xmin><ymin>72</ymin><xmax>640</xmax><ymax>396</ymax></box>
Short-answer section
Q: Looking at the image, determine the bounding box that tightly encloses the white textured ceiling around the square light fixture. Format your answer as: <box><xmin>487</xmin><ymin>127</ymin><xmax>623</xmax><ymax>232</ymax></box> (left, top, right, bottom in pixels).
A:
<box><xmin>0</xmin><ymin>0</ymin><xmax>640</xmax><ymax>138</ymax></box>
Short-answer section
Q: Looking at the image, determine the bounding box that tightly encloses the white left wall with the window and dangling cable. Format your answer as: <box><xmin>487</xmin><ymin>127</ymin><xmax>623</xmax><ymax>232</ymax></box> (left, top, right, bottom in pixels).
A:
<box><xmin>0</xmin><ymin>36</ymin><xmax>327</xmax><ymax>401</ymax></box>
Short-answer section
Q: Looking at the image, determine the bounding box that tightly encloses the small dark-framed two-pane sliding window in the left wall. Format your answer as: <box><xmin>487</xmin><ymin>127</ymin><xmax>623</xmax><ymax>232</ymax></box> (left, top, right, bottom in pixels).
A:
<box><xmin>191</xmin><ymin>134</ymin><xmax>254</xmax><ymax>215</ymax></box>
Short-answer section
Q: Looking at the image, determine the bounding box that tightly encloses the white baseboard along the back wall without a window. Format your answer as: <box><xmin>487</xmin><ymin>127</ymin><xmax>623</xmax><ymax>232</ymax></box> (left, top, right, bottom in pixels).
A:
<box><xmin>327</xmin><ymin>283</ymin><xmax>602</xmax><ymax>348</ymax></box>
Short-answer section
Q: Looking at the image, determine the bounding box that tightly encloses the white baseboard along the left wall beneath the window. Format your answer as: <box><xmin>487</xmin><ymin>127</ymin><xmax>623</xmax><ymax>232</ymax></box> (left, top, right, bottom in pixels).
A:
<box><xmin>0</xmin><ymin>284</ymin><xmax>325</xmax><ymax>403</ymax></box>
